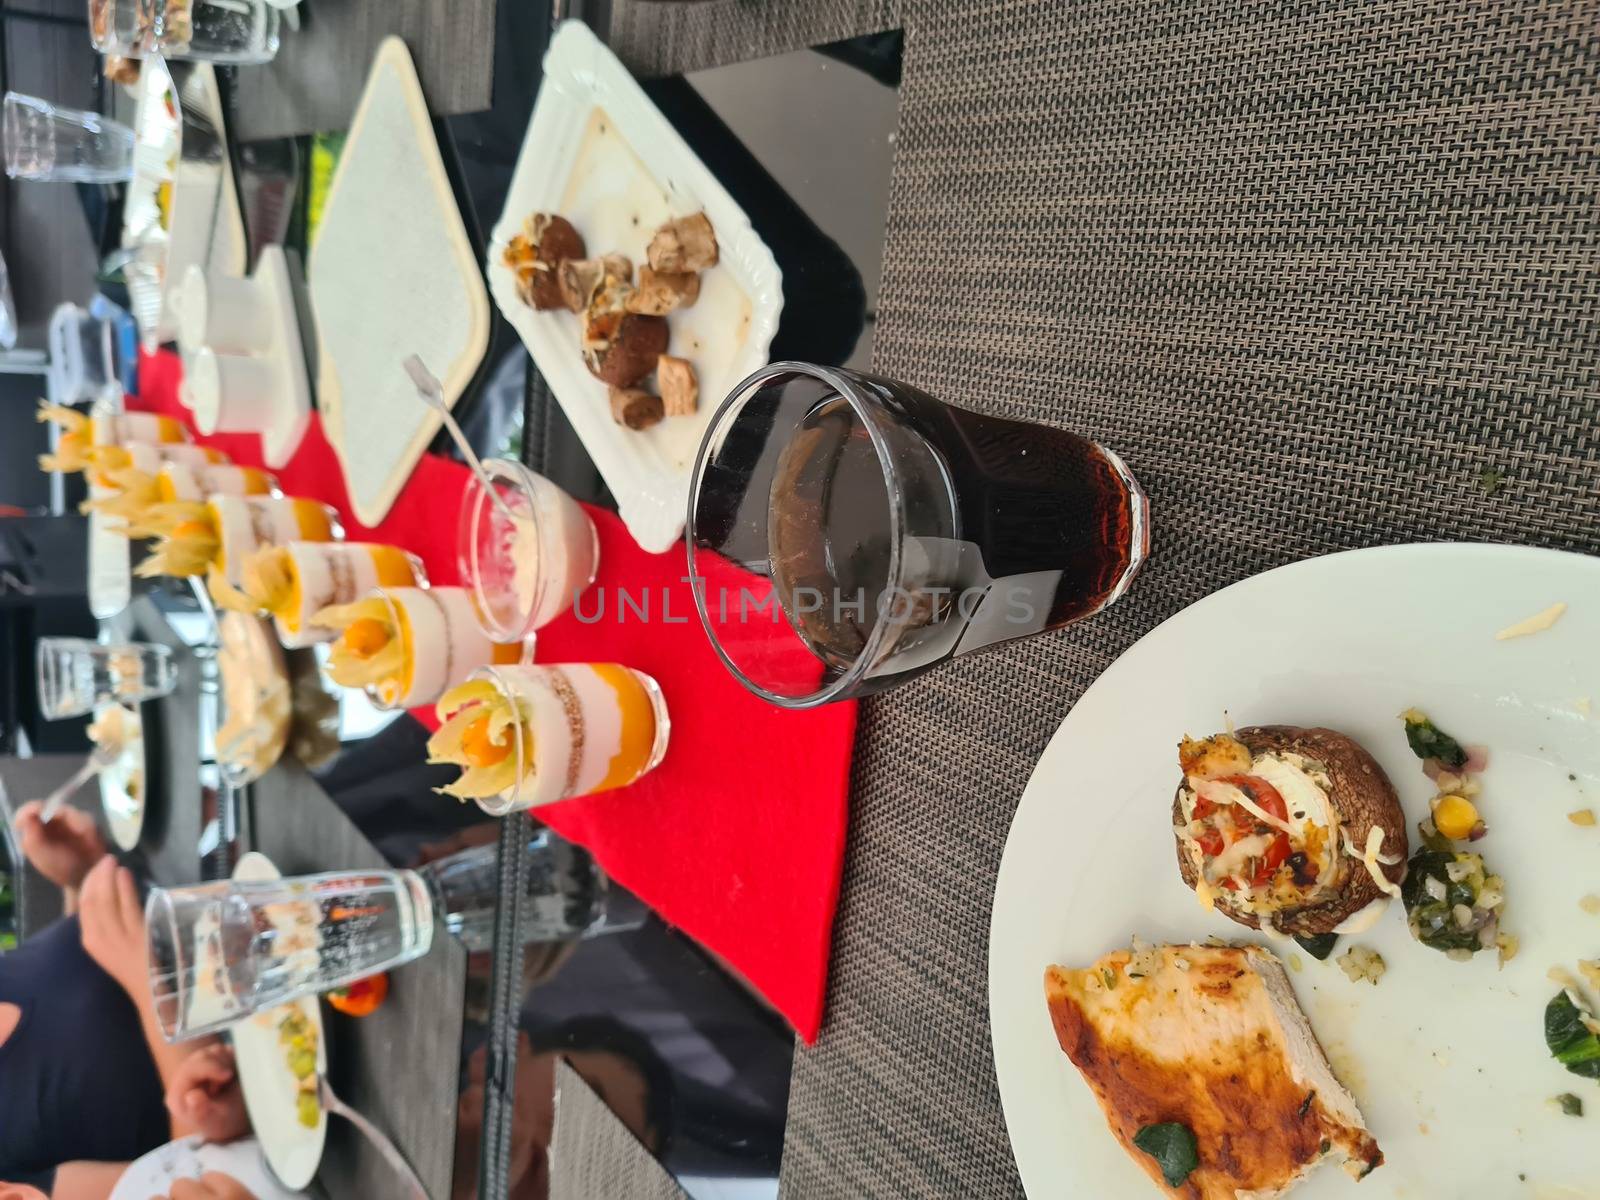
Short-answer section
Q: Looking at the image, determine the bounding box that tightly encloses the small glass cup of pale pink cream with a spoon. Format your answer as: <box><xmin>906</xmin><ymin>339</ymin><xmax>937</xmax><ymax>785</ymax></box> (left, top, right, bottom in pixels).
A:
<box><xmin>458</xmin><ymin>459</ymin><xmax>600</xmax><ymax>642</ymax></box>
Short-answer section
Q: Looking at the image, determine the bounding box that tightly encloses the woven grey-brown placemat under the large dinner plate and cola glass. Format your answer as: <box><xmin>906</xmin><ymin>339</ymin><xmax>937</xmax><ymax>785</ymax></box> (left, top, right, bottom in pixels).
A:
<box><xmin>618</xmin><ymin>0</ymin><xmax>1600</xmax><ymax>1200</ymax></box>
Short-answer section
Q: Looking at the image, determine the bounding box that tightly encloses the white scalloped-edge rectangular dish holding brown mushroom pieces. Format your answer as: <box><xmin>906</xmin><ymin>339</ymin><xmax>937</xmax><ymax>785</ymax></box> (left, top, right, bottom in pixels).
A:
<box><xmin>485</xmin><ymin>21</ymin><xmax>784</xmax><ymax>552</ymax></box>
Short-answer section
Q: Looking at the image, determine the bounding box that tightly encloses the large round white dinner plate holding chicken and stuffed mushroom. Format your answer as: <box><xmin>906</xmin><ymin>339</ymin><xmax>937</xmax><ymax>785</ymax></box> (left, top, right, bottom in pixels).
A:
<box><xmin>989</xmin><ymin>546</ymin><xmax>1600</xmax><ymax>1200</ymax></box>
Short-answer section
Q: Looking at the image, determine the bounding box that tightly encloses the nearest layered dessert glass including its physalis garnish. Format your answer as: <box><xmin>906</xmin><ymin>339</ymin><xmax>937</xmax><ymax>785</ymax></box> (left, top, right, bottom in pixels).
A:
<box><xmin>427</xmin><ymin>662</ymin><xmax>672</xmax><ymax>816</ymax></box>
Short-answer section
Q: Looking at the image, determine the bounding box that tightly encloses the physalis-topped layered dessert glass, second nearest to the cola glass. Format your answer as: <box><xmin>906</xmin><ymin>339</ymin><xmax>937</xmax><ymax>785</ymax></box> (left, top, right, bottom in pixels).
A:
<box><xmin>314</xmin><ymin>587</ymin><xmax>525</xmax><ymax>709</ymax></box>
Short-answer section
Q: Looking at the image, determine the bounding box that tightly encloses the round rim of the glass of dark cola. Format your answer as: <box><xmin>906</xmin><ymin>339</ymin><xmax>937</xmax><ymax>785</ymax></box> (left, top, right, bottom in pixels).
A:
<box><xmin>683</xmin><ymin>360</ymin><xmax>906</xmax><ymax>709</ymax></box>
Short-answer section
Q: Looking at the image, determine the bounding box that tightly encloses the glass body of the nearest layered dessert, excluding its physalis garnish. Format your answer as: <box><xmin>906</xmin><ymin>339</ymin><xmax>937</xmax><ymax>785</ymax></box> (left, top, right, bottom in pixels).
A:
<box><xmin>472</xmin><ymin>662</ymin><xmax>672</xmax><ymax>816</ymax></box>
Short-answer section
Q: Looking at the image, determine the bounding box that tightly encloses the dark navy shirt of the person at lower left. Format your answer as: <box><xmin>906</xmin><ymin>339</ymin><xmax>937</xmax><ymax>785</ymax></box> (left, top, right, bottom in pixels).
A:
<box><xmin>0</xmin><ymin>917</ymin><xmax>170</xmax><ymax>1192</ymax></box>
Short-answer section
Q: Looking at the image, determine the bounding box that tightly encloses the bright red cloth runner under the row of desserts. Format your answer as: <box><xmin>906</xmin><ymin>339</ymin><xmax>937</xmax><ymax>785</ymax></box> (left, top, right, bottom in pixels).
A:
<box><xmin>131</xmin><ymin>352</ymin><xmax>856</xmax><ymax>1043</ymax></box>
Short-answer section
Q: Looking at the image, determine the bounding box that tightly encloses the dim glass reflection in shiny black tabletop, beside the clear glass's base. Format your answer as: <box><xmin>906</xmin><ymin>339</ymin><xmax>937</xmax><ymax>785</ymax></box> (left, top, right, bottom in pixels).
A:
<box><xmin>419</xmin><ymin>829</ymin><xmax>646</xmax><ymax>952</ymax></box>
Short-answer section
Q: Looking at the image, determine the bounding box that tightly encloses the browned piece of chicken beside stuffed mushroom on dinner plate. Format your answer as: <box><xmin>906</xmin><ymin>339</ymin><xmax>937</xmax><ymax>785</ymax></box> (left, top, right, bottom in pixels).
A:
<box><xmin>1045</xmin><ymin>946</ymin><xmax>1384</xmax><ymax>1200</ymax></box>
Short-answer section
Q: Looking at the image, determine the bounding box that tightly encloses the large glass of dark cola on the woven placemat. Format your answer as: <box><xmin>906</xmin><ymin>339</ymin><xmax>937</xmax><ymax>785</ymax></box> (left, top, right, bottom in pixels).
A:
<box><xmin>688</xmin><ymin>363</ymin><xmax>1149</xmax><ymax>709</ymax></box>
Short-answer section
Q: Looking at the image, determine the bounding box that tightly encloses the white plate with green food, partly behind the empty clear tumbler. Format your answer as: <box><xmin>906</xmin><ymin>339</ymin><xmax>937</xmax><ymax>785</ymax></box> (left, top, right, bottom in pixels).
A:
<box><xmin>229</xmin><ymin>853</ymin><xmax>328</xmax><ymax>1190</ymax></box>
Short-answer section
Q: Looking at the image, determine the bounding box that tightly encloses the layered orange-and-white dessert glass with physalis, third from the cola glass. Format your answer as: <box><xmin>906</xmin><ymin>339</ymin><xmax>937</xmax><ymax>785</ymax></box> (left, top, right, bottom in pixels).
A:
<box><xmin>211</xmin><ymin>542</ymin><xmax>427</xmax><ymax>650</ymax></box>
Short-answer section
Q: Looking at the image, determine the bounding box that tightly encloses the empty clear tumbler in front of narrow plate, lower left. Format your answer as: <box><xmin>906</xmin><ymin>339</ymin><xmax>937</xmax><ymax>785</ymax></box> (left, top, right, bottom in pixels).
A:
<box><xmin>144</xmin><ymin>870</ymin><xmax>434</xmax><ymax>1042</ymax></box>
